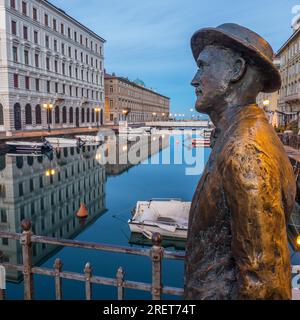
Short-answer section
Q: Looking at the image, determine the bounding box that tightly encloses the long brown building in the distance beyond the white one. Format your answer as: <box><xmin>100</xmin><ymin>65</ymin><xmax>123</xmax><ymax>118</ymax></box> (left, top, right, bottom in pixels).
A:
<box><xmin>105</xmin><ymin>74</ymin><xmax>170</xmax><ymax>123</ymax></box>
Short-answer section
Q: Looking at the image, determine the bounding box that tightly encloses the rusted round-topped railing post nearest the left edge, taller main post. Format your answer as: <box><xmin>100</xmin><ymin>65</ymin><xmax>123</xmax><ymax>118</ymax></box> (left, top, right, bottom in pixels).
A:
<box><xmin>21</xmin><ymin>220</ymin><xmax>34</xmax><ymax>300</ymax></box>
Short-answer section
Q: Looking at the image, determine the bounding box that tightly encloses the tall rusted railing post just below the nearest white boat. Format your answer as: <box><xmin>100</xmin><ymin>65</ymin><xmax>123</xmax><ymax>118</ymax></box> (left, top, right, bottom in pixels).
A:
<box><xmin>150</xmin><ymin>233</ymin><xmax>163</xmax><ymax>300</ymax></box>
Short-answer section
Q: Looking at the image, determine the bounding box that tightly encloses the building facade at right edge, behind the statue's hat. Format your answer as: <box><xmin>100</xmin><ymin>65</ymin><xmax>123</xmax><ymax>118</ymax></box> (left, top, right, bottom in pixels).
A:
<box><xmin>277</xmin><ymin>25</ymin><xmax>300</xmax><ymax>127</ymax></box>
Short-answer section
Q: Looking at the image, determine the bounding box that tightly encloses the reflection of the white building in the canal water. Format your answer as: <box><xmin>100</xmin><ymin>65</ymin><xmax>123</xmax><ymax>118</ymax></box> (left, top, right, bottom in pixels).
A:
<box><xmin>0</xmin><ymin>146</ymin><xmax>106</xmax><ymax>281</ymax></box>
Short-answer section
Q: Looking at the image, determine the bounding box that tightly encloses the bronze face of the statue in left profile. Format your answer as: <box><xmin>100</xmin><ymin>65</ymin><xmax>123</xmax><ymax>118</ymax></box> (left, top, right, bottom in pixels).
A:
<box><xmin>192</xmin><ymin>46</ymin><xmax>236</xmax><ymax>113</ymax></box>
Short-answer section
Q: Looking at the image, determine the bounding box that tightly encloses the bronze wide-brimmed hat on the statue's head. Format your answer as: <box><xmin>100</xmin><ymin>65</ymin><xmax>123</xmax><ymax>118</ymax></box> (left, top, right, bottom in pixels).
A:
<box><xmin>191</xmin><ymin>23</ymin><xmax>281</xmax><ymax>92</ymax></box>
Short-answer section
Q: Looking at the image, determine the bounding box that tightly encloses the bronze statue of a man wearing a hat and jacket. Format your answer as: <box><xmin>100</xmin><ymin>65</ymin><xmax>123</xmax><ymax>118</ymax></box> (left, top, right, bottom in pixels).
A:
<box><xmin>185</xmin><ymin>24</ymin><xmax>295</xmax><ymax>300</ymax></box>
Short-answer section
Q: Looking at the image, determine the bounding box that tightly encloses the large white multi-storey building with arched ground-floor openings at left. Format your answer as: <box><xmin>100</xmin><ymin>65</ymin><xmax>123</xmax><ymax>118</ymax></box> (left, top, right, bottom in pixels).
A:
<box><xmin>0</xmin><ymin>0</ymin><xmax>105</xmax><ymax>132</ymax></box>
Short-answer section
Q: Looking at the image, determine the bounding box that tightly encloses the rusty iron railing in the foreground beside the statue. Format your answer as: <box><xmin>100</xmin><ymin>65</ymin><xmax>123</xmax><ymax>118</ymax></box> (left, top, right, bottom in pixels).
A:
<box><xmin>0</xmin><ymin>220</ymin><xmax>185</xmax><ymax>300</ymax></box>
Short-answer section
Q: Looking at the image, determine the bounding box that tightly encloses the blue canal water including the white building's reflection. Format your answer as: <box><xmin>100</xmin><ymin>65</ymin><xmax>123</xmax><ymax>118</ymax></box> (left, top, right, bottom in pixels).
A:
<box><xmin>0</xmin><ymin>135</ymin><xmax>210</xmax><ymax>300</ymax></box>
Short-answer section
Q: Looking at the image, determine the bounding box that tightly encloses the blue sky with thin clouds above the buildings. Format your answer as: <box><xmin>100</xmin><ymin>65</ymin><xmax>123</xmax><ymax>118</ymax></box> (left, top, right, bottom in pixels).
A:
<box><xmin>50</xmin><ymin>0</ymin><xmax>300</xmax><ymax>116</ymax></box>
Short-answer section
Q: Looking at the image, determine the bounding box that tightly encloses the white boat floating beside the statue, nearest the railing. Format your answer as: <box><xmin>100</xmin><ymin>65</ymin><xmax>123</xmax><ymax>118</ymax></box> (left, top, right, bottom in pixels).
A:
<box><xmin>128</xmin><ymin>199</ymin><xmax>191</xmax><ymax>239</ymax></box>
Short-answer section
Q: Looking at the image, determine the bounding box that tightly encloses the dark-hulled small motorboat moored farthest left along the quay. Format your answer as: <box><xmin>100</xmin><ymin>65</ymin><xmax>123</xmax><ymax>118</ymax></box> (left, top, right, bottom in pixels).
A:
<box><xmin>6</xmin><ymin>140</ymin><xmax>53</xmax><ymax>154</ymax></box>
